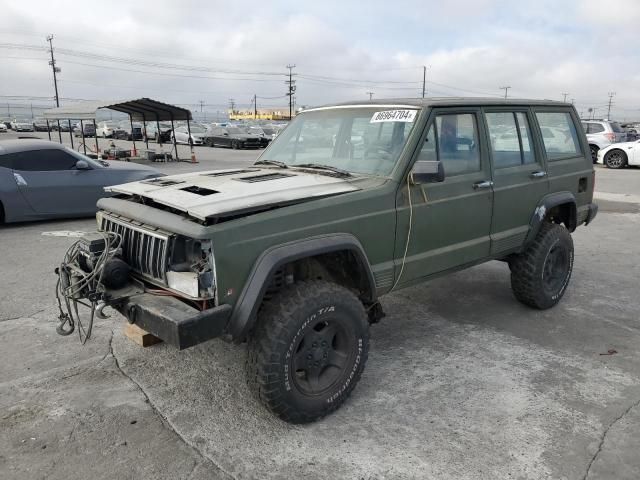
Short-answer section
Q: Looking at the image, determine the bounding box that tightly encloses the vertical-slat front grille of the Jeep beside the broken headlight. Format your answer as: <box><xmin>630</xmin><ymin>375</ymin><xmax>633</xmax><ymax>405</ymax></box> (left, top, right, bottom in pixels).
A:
<box><xmin>102</xmin><ymin>215</ymin><xmax>173</xmax><ymax>283</ymax></box>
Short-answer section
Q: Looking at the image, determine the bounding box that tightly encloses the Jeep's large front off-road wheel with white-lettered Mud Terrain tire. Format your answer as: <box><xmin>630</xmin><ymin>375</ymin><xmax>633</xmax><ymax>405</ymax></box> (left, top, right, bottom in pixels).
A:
<box><xmin>246</xmin><ymin>280</ymin><xmax>369</xmax><ymax>423</ymax></box>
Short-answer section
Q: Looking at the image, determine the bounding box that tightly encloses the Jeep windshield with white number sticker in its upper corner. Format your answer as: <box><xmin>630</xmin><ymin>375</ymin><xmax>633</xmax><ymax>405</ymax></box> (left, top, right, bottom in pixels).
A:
<box><xmin>260</xmin><ymin>106</ymin><xmax>418</xmax><ymax>176</ymax></box>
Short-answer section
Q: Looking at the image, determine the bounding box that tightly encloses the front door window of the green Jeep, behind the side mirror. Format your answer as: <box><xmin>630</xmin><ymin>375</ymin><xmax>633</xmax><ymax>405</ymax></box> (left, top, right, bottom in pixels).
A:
<box><xmin>418</xmin><ymin>113</ymin><xmax>480</xmax><ymax>177</ymax></box>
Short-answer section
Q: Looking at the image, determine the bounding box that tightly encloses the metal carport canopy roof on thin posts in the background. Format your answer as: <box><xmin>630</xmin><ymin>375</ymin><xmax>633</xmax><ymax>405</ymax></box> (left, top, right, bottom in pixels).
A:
<box><xmin>43</xmin><ymin>98</ymin><xmax>193</xmax><ymax>121</ymax></box>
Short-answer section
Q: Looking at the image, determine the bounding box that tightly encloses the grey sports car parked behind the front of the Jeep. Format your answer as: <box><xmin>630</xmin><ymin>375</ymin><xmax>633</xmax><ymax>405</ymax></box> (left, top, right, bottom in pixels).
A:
<box><xmin>0</xmin><ymin>139</ymin><xmax>164</xmax><ymax>223</ymax></box>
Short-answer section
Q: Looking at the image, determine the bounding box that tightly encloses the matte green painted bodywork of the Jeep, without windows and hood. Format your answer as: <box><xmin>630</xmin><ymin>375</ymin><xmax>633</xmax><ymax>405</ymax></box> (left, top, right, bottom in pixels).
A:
<box><xmin>100</xmin><ymin>99</ymin><xmax>594</xmax><ymax>342</ymax></box>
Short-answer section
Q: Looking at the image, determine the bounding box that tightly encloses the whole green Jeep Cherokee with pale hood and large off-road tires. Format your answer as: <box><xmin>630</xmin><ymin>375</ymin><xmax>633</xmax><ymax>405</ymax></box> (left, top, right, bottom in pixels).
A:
<box><xmin>58</xmin><ymin>98</ymin><xmax>597</xmax><ymax>423</ymax></box>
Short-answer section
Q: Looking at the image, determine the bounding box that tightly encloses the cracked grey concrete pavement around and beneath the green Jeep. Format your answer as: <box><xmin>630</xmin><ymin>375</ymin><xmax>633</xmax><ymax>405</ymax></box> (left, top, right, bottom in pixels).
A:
<box><xmin>0</xmin><ymin>132</ymin><xmax>640</xmax><ymax>480</ymax></box>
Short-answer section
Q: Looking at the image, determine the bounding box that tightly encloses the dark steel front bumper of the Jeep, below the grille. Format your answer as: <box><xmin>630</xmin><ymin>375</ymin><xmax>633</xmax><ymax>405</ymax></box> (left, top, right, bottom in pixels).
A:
<box><xmin>114</xmin><ymin>293</ymin><xmax>231</xmax><ymax>350</ymax></box>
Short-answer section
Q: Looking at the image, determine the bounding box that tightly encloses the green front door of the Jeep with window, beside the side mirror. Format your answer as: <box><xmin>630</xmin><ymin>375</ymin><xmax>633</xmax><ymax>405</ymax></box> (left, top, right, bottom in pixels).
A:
<box><xmin>394</xmin><ymin>108</ymin><xmax>493</xmax><ymax>285</ymax></box>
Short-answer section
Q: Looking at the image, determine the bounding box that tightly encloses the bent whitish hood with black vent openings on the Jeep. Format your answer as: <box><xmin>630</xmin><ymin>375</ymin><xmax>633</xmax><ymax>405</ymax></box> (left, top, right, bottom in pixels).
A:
<box><xmin>105</xmin><ymin>168</ymin><xmax>359</xmax><ymax>220</ymax></box>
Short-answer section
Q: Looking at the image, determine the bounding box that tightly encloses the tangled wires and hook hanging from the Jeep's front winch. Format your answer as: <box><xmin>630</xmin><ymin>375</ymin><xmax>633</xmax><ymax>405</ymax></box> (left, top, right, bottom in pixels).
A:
<box><xmin>56</xmin><ymin>232</ymin><xmax>122</xmax><ymax>345</ymax></box>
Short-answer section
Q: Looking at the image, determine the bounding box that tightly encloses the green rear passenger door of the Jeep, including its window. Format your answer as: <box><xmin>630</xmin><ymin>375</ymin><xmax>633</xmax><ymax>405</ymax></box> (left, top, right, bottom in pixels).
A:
<box><xmin>484</xmin><ymin>107</ymin><xmax>549</xmax><ymax>255</ymax></box>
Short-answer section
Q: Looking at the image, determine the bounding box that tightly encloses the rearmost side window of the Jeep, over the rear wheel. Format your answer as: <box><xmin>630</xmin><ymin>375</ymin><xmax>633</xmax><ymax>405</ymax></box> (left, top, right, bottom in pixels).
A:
<box><xmin>536</xmin><ymin>112</ymin><xmax>582</xmax><ymax>160</ymax></box>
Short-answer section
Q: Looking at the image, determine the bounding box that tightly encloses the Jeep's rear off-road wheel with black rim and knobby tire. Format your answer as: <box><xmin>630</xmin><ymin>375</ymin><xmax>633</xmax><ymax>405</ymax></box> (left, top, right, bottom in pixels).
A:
<box><xmin>509</xmin><ymin>222</ymin><xmax>573</xmax><ymax>310</ymax></box>
